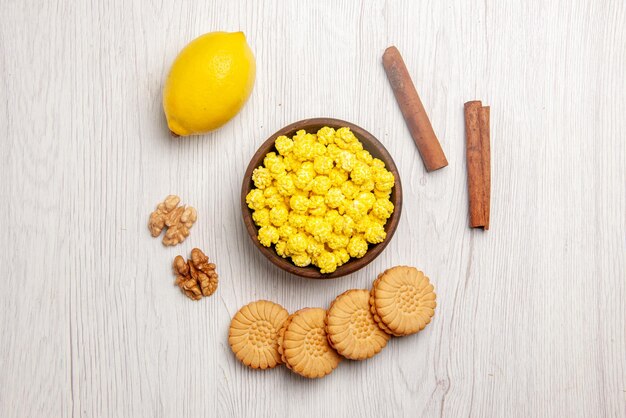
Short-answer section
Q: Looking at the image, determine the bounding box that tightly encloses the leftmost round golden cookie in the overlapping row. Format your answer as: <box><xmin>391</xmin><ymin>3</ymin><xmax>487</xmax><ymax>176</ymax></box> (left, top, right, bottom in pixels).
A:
<box><xmin>228</xmin><ymin>300</ymin><xmax>289</xmax><ymax>369</ymax></box>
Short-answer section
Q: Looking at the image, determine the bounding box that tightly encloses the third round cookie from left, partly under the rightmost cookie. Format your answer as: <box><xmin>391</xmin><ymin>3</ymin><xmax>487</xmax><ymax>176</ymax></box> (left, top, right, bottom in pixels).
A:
<box><xmin>326</xmin><ymin>289</ymin><xmax>390</xmax><ymax>360</ymax></box>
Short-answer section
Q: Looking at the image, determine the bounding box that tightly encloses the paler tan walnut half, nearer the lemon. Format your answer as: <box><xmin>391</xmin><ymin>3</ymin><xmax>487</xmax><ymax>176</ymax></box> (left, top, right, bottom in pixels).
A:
<box><xmin>148</xmin><ymin>195</ymin><xmax>198</xmax><ymax>245</ymax></box>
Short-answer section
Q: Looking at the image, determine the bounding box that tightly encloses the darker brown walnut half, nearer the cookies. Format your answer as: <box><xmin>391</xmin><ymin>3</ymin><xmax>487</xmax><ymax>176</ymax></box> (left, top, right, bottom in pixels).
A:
<box><xmin>173</xmin><ymin>248</ymin><xmax>218</xmax><ymax>300</ymax></box>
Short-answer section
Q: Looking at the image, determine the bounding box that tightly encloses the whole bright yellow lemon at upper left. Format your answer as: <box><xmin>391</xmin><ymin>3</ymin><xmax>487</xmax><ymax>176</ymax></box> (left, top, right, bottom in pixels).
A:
<box><xmin>163</xmin><ymin>32</ymin><xmax>256</xmax><ymax>136</ymax></box>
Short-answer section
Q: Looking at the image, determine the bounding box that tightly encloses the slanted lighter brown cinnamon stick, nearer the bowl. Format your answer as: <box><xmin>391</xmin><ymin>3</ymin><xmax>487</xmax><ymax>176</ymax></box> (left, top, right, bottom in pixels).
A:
<box><xmin>383</xmin><ymin>46</ymin><xmax>448</xmax><ymax>171</ymax></box>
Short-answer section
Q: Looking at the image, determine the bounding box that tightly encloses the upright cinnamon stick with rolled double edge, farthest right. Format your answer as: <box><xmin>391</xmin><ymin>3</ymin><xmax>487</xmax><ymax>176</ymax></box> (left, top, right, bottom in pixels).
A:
<box><xmin>464</xmin><ymin>100</ymin><xmax>491</xmax><ymax>229</ymax></box>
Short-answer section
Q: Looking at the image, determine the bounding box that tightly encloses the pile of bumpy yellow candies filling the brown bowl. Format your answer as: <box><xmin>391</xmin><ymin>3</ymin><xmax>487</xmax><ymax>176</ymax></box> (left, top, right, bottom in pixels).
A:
<box><xmin>246</xmin><ymin>126</ymin><xmax>395</xmax><ymax>273</ymax></box>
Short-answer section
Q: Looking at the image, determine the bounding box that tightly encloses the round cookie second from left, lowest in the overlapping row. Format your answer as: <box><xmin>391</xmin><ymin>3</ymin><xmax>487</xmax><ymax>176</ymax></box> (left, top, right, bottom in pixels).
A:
<box><xmin>281</xmin><ymin>308</ymin><xmax>341</xmax><ymax>379</ymax></box>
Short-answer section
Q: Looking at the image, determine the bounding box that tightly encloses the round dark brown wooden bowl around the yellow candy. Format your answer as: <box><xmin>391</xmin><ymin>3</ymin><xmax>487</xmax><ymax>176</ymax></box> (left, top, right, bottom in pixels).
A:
<box><xmin>241</xmin><ymin>118</ymin><xmax>402</xmax><ymax>279</ymax></box>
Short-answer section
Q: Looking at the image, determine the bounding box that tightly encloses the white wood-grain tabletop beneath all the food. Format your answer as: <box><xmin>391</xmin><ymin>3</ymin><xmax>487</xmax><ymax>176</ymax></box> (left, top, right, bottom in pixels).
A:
<box><xmin>0</xmin><ymin>0</ymin><xmax>626</xmax><ymax>418</ymax></box>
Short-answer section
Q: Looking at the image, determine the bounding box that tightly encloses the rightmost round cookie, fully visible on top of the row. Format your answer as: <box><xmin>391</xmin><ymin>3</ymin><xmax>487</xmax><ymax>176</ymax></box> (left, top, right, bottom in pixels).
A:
<box><xmin>370</xmin><ymin>266</ymin><xmax>437</xmax><ymax>337</ymax></box>
